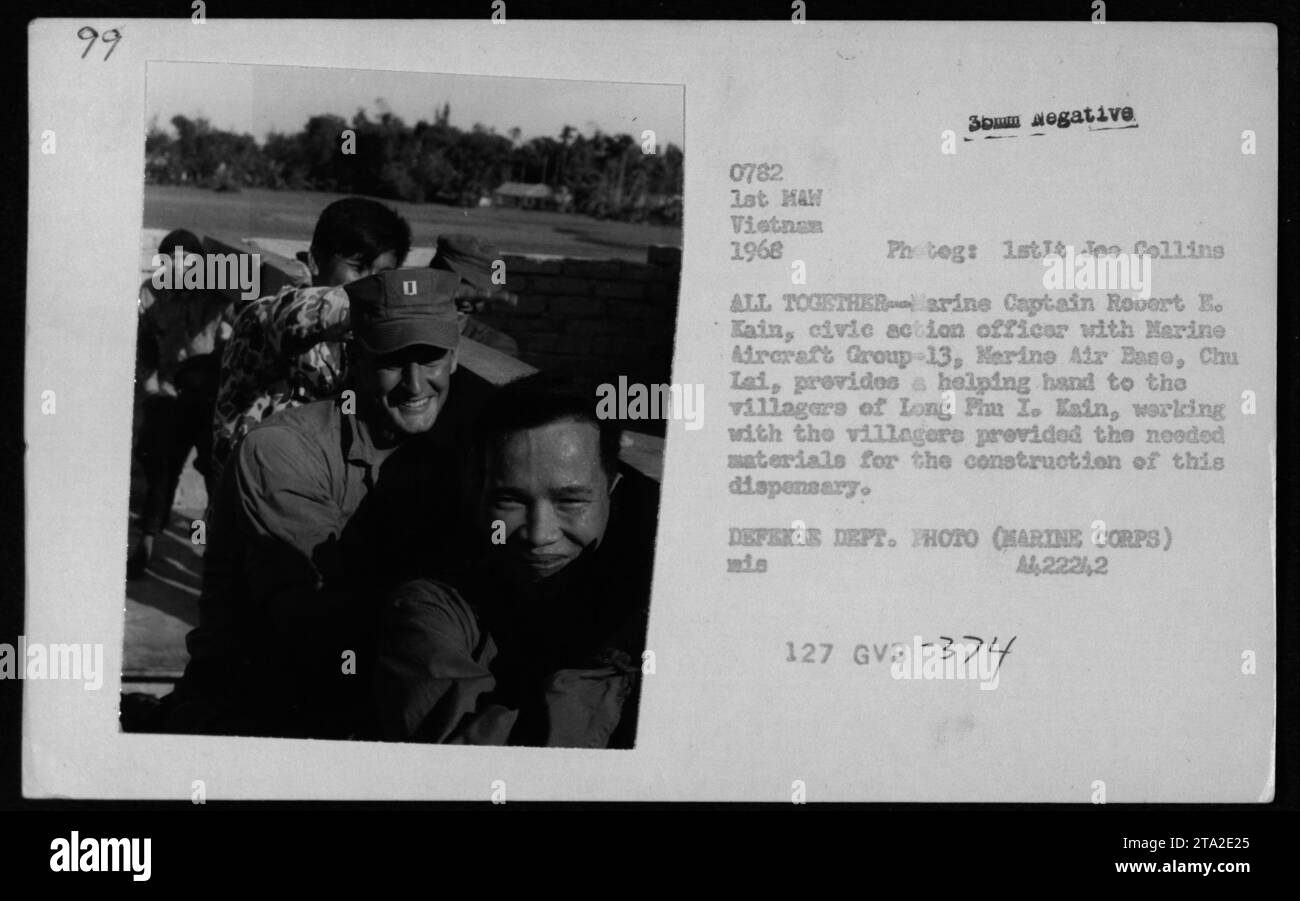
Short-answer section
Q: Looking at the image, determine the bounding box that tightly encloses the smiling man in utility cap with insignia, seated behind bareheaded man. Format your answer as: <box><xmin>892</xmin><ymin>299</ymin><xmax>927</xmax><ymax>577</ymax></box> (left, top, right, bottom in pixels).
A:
<box><xmin>168</xmin><ymin>261</ymin><xmax>459</xmax><ymax>737</ymax></box>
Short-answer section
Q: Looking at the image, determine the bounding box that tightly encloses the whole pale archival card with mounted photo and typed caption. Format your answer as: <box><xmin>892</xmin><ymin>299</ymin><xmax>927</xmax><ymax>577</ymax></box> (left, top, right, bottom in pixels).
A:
<box><xmin>22</xmin><ymin>17</ymin><xmax>1279</xmax><ymax>805</ymax></box>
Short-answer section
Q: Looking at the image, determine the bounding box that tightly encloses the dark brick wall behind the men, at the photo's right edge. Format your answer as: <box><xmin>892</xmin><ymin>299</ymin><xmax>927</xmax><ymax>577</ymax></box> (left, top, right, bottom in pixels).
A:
<box><xmin>478</xmin><ymin>247</ymin><xmax>681</xmax><ymax>384</ymax></box>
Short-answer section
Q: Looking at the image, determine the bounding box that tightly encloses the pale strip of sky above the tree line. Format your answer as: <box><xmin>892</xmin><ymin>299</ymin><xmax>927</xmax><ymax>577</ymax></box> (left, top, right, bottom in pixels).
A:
<box><xmin>146</xmin><ymin>62</ymin><xmax>684</xmax><ymax>147</ymax></box>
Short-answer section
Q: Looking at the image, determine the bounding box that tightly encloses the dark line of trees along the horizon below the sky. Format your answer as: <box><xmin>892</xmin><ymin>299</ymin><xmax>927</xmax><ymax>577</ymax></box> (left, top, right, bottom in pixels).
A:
<box><xmin>144</xmin><ymin>104</ymin><xmax>683</xmax><ymax>222</ymax></box>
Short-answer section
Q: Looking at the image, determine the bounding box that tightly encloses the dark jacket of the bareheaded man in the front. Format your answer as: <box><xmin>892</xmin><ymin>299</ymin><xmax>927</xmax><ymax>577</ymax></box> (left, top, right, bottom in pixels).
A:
<box><xmin>374</xmin><ymin>468</ymin><xmax>659</xmax><ymax>748</ymax></box>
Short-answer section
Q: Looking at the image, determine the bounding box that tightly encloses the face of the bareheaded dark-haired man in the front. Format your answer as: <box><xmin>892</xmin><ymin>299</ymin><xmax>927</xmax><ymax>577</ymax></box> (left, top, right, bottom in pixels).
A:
<box><xmin>484</xmin><ymin>420</ymin><xmax>616</xmax><ymax>581</ymax></box>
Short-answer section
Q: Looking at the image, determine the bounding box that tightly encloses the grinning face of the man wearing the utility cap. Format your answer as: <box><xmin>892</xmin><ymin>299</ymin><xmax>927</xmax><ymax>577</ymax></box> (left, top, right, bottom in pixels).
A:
<box><xmin>355</xmin><ymin>345</ymin><xmax>456</xmax><ymax>441</ymax></box>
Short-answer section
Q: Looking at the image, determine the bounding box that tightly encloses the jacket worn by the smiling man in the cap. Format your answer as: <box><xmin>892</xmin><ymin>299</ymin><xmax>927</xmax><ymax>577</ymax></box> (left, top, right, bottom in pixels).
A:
<box><xmin>176</xmin><ymin>400</ymin><xmax>459</xmax><ymax>737</ymax></box>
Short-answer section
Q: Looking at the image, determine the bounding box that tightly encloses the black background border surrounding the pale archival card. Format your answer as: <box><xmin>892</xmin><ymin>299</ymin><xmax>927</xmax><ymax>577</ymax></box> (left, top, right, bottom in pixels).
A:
<box><xmin>0</xmin><ymin>0</ymin><xmax>1300</xmax><ymax>873</ymax></box>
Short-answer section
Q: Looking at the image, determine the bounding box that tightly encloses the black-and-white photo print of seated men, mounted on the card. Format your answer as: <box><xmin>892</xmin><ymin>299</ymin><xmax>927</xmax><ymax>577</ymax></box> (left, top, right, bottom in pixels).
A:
<box><xmin>121</xmin><ymin>62</ymin><xmax>684</xmax><ymax>749</ymax></box>
